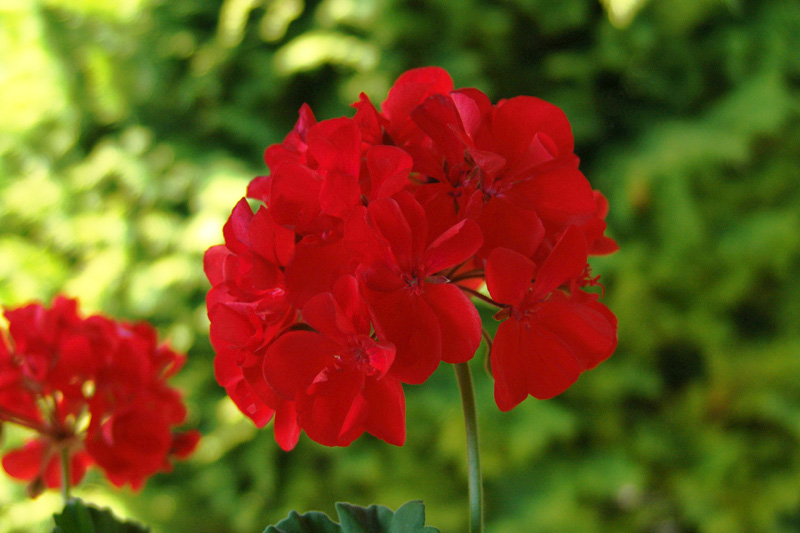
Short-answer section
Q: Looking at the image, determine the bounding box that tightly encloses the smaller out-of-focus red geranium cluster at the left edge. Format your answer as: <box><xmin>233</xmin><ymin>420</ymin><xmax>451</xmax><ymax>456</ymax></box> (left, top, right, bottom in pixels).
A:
<box><xmin>0</xmin><ymin>296</ymin><xmax>199</xmax><ymax>496</ymax></box>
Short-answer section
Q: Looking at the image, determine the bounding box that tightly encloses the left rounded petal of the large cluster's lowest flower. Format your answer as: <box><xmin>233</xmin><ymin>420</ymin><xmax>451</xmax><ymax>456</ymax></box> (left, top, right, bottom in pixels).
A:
<box><xmin>263</xmin><ymin>331</ymin><xmax>340</xmax><ymax>400</ymax></box>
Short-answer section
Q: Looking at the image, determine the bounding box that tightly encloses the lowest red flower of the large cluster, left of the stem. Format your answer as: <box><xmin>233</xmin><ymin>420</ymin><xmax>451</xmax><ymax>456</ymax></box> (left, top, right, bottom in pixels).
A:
<box><xmin>263</xmin><ymin>276</ymin><xmax>405</xmax><ymax>446</ymax></box>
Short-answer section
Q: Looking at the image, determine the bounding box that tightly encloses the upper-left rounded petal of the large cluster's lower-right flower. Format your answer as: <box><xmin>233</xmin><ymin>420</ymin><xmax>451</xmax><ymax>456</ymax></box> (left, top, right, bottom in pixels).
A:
<box><xmin>486</xmin><ymin>248</ymin><xmax>536</xmax><ymax>305</ymax></box>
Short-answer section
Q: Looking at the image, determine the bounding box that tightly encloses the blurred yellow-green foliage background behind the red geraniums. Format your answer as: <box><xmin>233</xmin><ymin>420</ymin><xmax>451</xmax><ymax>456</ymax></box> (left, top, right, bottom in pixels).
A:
<box><xmin>0</xmin><ymin>0</ymin><xmax>800</xmax><ymax>533</ymax></box>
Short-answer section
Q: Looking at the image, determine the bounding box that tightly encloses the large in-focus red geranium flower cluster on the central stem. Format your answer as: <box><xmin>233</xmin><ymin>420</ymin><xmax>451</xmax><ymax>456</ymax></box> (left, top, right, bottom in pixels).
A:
<box><xmin>205</xmin><ymin>68</ymin><xmax>617</xmax><ymax>450</ymax></box>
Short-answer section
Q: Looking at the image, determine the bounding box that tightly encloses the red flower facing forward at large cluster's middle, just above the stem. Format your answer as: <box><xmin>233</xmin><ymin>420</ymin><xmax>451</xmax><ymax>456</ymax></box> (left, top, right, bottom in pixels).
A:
<box><xmin>345</xmin><ymin>192</ymin><xmax>481</xmax><ymax>383</ymax></box>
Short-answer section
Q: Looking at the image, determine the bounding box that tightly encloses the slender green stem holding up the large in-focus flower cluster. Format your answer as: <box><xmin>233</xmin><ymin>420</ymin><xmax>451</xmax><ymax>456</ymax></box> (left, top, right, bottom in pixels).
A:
<box><xmin>453</xmin><ymin>363</ymin><xmax>483</xmax><ymax>533</ymax></box>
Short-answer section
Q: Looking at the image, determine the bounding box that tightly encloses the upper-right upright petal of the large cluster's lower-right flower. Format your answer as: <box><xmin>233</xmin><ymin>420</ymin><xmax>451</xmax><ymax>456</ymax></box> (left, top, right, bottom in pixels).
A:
<box><xmin>533</xmin><ymin>226</ymin><xmax>588</xmax><ymax>299</ymax></box>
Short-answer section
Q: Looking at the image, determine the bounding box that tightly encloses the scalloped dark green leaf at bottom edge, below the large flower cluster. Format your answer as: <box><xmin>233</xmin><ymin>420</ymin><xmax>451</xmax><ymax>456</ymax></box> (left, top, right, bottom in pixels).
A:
<box><xmin>264</xmin><ymin>500</ymin><xmax>439</xmax><ymax>533</ymax></box>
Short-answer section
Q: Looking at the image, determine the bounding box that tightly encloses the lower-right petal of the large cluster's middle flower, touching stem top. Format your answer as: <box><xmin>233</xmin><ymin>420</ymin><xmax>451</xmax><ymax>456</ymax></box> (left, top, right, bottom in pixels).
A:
<box><xmin>423</xmin><ymin>283</ymin><xmax>481</xmax><ymax>363</ymax></box>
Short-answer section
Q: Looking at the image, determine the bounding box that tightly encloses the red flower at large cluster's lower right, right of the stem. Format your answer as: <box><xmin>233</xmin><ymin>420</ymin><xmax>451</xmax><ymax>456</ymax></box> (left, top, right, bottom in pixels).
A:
<box><xmin>486</xmin><ymin>226</ymin><xmax>617</xmax><ymax>411</ymax></box>
